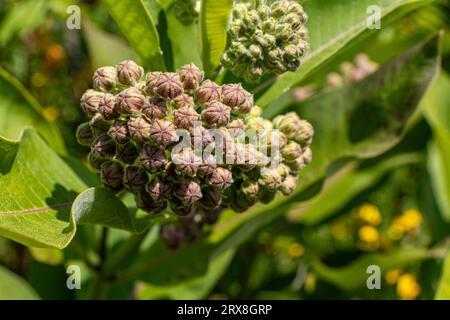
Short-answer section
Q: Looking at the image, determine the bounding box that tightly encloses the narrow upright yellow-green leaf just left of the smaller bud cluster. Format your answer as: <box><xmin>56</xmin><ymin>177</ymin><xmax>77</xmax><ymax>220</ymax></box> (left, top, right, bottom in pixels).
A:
<box><xmin>200</xmin><ymin>0</ymin><xmax>234</xmax><ymax>75</ymax></box>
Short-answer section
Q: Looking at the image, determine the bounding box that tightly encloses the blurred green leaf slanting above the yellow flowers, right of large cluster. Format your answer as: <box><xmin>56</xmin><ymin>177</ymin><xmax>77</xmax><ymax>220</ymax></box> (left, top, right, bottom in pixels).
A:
<box><xmin>289</xmin><ymin>154</ymin><xmax>421</xmax><ymax>225</ymax></box>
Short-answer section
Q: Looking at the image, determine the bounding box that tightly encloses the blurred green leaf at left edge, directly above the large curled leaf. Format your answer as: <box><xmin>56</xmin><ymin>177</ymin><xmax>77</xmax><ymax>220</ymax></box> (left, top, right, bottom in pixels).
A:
<box><xmin>0</xmin><ymin>68</ymin><xmax>66</xmax><ymax>154</ymax></box>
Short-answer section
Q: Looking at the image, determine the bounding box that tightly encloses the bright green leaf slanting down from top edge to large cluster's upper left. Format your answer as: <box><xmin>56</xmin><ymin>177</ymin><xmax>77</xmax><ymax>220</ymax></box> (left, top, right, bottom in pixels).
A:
<box><xmin>103</xmin><ymin>0</ymin><xmax>165</xmax><ymax>71</ymax></box>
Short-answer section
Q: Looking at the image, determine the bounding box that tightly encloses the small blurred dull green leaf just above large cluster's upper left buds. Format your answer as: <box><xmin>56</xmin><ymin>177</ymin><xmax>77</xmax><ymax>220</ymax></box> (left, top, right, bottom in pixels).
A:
<box><xmin>82</xmin><ymin>20</ymin><xmax>139</xmax><ymax>69</ymax></box>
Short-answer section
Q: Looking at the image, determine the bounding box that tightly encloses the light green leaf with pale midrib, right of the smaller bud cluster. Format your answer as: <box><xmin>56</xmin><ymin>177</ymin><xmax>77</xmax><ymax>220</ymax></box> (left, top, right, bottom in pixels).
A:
<box><xmin>257</xmin><ymin>0</ymin><xmax>430</xmax><ymax>108</ymax></box>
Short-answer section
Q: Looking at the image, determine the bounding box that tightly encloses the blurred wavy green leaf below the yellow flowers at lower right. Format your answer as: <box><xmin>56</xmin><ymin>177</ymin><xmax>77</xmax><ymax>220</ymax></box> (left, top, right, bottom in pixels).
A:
<box><xmin>310</xmin><ymin>247</ymin><xmax>431</xmax><ymax>291</ymax></box>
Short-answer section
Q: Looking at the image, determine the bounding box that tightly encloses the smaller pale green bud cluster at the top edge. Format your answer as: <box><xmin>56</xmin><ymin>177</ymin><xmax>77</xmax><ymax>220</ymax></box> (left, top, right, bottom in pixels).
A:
<box><xmin>221</xmin><ymin>0</ymin><xmax>308</xmax><ymax>83</ymax></box>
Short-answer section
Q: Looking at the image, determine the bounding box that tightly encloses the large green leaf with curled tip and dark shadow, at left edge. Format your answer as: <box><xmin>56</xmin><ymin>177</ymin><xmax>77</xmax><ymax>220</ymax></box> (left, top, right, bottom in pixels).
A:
<box><xmin>0</xmin><ymin>129</ymin><xmax>162</xmax><ymax>249</ymax></box>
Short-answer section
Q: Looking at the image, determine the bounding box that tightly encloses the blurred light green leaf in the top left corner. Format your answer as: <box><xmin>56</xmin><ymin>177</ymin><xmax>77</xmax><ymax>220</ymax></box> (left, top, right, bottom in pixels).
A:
<box><xmin>0</xmin><ymin>0</ymin><xmax>49</xmax><ymax>46</ymax></box>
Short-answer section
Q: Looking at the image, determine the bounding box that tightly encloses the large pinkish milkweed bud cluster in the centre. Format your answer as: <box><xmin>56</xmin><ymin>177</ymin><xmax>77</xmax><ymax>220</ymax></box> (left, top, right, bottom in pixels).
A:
<box><xmin>76</xmin><ymin>61</ymin><xmax>313</xmax><ymax>248</ymax></box>
